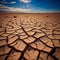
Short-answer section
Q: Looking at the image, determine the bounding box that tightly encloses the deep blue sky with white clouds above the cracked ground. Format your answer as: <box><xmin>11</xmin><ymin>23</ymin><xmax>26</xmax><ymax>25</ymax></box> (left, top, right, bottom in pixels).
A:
<box><xmin>0</xmin><ymin>0</ymin><xmax>60</xmax><ymax>13</ymax></box>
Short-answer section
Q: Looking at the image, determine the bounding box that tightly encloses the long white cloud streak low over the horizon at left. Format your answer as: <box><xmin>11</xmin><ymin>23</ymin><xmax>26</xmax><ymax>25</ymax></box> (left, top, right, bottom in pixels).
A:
<box><xmin>0</xmin><ymin>4</ymin><xmax>31</xmax><ymax>13</ymax></box>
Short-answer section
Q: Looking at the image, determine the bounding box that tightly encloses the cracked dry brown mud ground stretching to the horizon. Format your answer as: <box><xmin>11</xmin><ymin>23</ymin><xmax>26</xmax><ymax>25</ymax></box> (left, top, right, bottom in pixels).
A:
<box><xmin>0</xmin><ymin>13</ymin><xmax>60</xmax><ymax>60</ymax></box>
